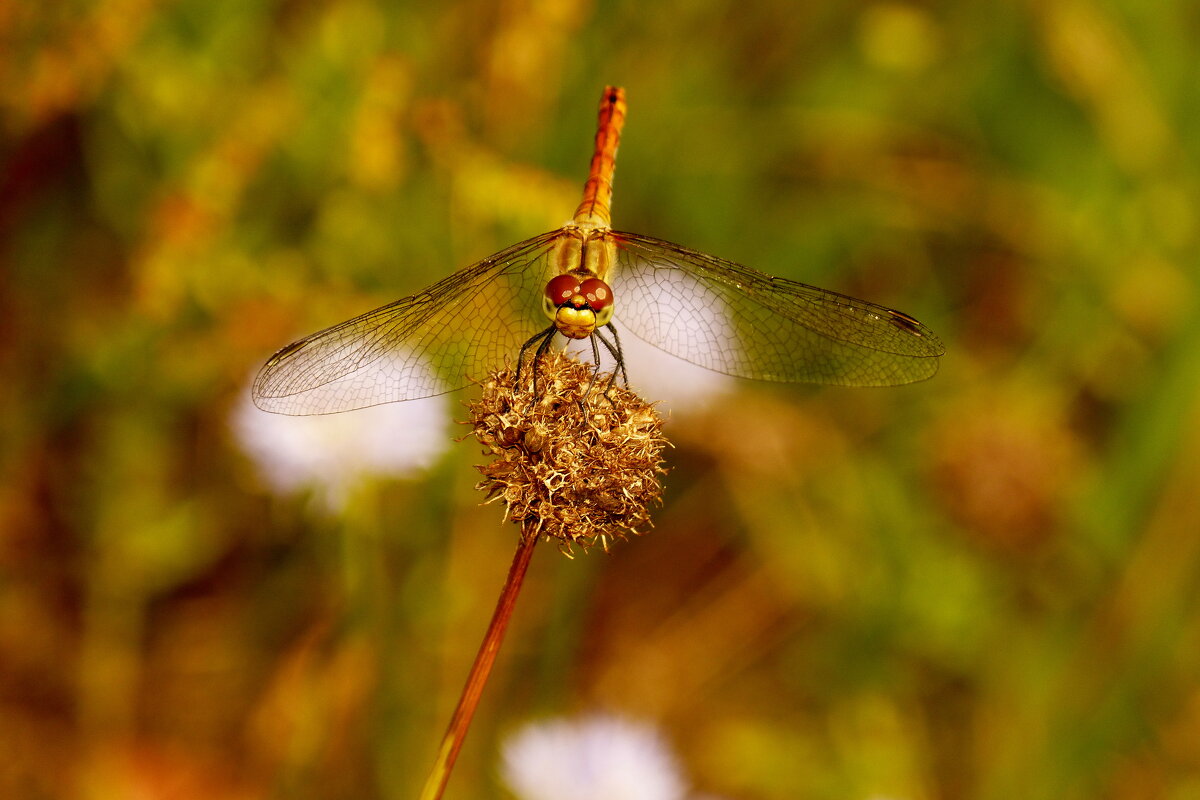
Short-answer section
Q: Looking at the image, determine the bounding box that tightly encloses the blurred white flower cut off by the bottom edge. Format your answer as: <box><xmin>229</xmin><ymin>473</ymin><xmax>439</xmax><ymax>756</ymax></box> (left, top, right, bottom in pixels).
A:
<box><xmin>503</xmin><ymin>715</ymin><xmax>685</xmax><ymax>800</ymax></box>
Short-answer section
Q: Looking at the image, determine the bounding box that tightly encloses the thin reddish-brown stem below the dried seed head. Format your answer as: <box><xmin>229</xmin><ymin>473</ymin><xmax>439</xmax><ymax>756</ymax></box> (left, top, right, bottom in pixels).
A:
<box><xmin>420</xmin><ymin>531</ymin><xmax>538</xmax><ymax>800</ymax></box>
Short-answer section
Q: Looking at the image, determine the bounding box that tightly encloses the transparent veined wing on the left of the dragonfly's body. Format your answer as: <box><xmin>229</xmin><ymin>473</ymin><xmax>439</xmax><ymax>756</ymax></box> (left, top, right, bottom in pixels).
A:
<box><xmin>251</xmin><ymin>230</ymin><xmax>559</xmax><ymax>415</ymax></box>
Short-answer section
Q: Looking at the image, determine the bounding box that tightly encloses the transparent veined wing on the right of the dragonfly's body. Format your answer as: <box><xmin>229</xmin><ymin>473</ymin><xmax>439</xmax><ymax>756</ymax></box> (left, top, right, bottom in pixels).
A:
<box><xmin>611</xmin><ymin>231</ymin><xmax>944</xmax><ymax>386</ymax></box>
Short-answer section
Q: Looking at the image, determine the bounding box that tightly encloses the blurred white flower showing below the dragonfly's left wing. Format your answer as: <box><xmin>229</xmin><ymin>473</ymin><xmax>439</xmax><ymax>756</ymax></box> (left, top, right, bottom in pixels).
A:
<box><xmin>230</xmin><ymin>379</ymin><xmax>450</xmax><ymax>511</ymax></box>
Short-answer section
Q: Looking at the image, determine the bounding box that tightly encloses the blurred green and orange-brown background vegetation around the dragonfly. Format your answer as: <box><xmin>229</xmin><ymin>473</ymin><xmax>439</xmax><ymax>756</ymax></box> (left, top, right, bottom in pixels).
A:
<box><xmin>0</xmin><ymin>0</ymin><xmax>1200</xmax><ymax>800</ymax></box>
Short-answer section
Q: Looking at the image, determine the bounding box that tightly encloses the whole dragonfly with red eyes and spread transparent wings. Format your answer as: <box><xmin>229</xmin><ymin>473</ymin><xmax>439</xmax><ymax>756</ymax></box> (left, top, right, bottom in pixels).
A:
<box><xmin>251</xmin><ymin>86</ymin><xmax>944</xmax><ymax>415</ymax></box>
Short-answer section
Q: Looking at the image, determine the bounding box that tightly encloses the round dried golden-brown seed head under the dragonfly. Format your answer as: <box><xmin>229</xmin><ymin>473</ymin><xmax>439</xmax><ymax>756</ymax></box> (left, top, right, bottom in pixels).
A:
<box><xmin>467</xmin><ymin>354</ymin><xmax>667</xmax><ymax>554</ymax></box>
